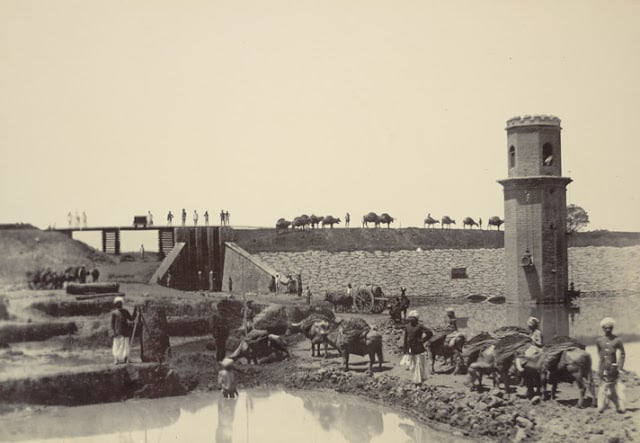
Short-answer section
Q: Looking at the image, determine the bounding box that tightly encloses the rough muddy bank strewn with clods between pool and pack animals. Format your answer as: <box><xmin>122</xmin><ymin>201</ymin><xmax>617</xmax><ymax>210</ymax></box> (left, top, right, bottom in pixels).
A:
<box><xmin>172</xmin><ymin>353</ymin><xmax>640</xmax><ymax>443</ymax></box>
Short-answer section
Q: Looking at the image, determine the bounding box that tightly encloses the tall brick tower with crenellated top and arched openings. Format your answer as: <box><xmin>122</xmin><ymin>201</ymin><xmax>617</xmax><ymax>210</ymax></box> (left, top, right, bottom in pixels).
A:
<box><xmin>499</xmin><ymin>115</ymin><xmax>571</xmax><ymax>338</ymax></box>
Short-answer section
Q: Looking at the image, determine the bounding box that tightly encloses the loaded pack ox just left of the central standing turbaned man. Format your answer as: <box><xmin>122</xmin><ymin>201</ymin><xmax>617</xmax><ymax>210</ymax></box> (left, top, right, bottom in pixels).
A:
<box><xmin>336</xmin><ymin>318</ymin><xmax>382</xmax><ymax>371</ymax></box>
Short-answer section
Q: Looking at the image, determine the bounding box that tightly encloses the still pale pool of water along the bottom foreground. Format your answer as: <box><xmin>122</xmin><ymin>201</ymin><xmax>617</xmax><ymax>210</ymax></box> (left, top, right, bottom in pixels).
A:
<box><xmin>0</xmin><ymin>390</ymin><xmax>470</xmax><ymax>443</ymax></box>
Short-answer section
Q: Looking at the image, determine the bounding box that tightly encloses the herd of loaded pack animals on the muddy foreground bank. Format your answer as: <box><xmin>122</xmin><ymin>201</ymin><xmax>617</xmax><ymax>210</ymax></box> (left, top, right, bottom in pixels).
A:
<box><xmin>233</xmin><ymin>300</ymin><xmax>596</xmax><ymax>407</ymax></box>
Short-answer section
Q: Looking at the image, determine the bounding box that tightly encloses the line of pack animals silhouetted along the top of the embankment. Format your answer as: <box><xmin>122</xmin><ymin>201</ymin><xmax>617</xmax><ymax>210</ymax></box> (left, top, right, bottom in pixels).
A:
<box><xmin>276</xmin><ymin>212</ymin><xmax>504</xmax><ymax>232</ymax></box>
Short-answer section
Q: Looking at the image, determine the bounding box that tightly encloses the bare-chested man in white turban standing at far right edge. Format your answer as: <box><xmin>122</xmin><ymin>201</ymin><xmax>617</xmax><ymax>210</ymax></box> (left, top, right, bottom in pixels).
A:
<box><xmin>596</xmin><ymin>317</ymin><xmax>625</xmax><ymax>413</ymax></box>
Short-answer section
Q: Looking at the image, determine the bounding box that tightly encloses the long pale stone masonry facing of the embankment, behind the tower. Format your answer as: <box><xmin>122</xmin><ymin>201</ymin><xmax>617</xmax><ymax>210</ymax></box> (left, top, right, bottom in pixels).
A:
<box><xmin>254</xmin><ymin>246</ymin><xmax>640</xmax><ymax>299</ymax></box>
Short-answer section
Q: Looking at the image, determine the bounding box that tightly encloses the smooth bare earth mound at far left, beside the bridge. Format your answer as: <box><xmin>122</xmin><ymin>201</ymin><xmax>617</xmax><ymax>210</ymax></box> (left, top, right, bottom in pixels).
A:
<box><xmin>0</xmin><ymin>229</ymin><xmax>115</xmax><ymax>286</ymax></box>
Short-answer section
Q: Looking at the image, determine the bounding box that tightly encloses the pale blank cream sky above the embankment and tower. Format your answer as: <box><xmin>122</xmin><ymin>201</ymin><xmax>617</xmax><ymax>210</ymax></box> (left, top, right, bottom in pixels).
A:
<box><xmin>0</xmin><ymin>0</ymin><xmax>640</xmax><ymax>231</ymax></box>
